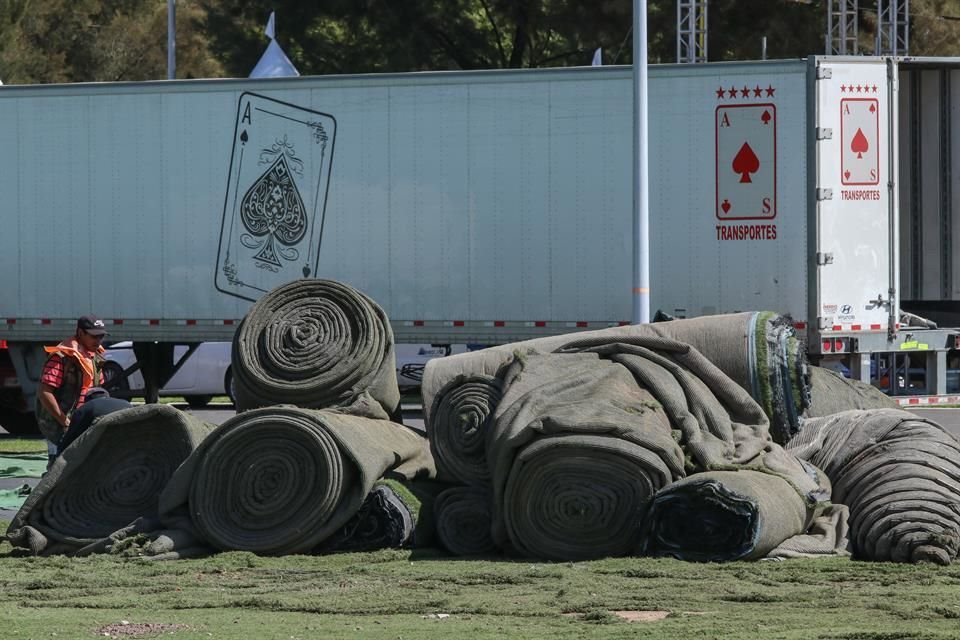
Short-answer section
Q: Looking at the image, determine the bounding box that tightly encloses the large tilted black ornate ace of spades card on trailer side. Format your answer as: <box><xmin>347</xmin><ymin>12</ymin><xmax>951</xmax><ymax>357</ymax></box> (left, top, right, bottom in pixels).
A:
<box><xmin>214</xmin><ymin>93</ymin><xmax>336</xmax><ymax>300</ymax></box>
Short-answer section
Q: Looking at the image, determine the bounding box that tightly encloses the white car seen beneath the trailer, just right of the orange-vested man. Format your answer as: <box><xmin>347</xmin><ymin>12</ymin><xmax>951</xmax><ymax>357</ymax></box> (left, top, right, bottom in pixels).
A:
<box><xmin>103</xmin><ymin>342</ymin><xmax>233</xmax><ymax>407</ymax></box>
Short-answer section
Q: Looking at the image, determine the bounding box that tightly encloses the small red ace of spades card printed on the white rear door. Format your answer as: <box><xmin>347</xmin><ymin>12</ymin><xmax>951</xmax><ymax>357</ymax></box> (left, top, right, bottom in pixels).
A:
<box><xmin>840</xmin><ymin>98</ymin><xmax>880</xmax><ymax>185</ymax></box>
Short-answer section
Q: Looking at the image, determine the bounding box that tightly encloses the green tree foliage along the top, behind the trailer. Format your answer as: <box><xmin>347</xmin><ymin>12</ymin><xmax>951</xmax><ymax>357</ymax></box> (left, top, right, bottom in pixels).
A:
<box><xmin>0</xmin><ymin>0</ymin><xmax>960</xmax><ymax>83</ymax></box>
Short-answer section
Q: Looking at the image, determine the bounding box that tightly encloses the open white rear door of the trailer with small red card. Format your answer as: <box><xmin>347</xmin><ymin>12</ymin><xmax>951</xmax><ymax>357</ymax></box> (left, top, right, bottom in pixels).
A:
<box><xmin>811</xmin><ymin>58</ymin><xmax>897</xmax><ymax>335</ymax></box>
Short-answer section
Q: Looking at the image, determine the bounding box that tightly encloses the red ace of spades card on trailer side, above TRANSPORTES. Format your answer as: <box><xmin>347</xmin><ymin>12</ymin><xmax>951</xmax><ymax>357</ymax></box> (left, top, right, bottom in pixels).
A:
<box><xmin>716</xmin><ymin>104</ymin><xmax>777</xmax><ymax>220</ymax></box>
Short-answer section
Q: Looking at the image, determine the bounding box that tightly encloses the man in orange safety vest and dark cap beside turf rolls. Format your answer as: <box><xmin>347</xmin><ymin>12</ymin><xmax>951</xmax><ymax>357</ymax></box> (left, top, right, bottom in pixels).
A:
<box><xmin>36</xmin><ymin>315</ymin><xmax>107</xmax><ymax>468</ymax></box>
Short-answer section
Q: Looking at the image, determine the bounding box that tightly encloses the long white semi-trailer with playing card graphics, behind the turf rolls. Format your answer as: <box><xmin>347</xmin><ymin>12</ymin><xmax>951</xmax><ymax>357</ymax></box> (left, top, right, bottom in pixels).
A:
<box><xmin>0</xmin><ymin>57</ymin><xmax>960</xmax><ymax>432</ymax></box>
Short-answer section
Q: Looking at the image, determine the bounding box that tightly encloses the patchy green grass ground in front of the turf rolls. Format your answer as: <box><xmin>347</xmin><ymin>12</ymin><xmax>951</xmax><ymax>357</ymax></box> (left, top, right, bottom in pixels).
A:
<box><xmin>0</xmin><ymin>536</ymin><xmax>960</xmax><ymax>640</ymax></box>
